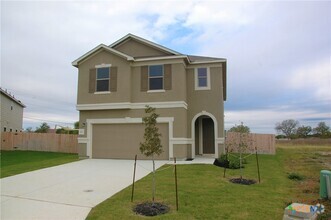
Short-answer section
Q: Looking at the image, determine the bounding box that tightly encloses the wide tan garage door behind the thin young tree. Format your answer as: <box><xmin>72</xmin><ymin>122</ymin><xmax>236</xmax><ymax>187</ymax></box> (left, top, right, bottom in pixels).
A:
<box><xmin>92</xmin><ymin>124</ymin><xmax>169</xmax><ymax>160</ymax></box>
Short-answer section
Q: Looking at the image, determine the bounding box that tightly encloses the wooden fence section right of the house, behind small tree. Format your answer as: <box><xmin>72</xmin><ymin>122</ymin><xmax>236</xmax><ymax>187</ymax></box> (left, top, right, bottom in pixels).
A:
<box><xmin>225</xmin><ymin>132</ymin><xmax>276</xmax><ymax>154</ymax></box>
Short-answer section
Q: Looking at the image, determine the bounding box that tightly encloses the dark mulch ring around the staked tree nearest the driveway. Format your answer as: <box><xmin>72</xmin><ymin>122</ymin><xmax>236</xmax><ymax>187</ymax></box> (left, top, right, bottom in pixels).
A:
<box><xmin>133</xmin><ymin>202</ymin><xmax>169</xmax><ymax>216</ymax></box>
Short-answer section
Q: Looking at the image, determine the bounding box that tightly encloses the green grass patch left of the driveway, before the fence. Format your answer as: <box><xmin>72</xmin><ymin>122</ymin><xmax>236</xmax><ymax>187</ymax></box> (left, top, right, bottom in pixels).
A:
<box><xmin>0</xmin><ymin>151</ymin><xmax>78</xmax><ymax>178</ymax></box>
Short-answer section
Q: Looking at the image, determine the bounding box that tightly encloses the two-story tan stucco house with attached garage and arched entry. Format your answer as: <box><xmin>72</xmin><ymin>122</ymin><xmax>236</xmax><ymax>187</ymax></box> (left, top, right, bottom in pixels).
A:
<box><xmin>72</xmin><ymin>34</ymin><xmax>226</xmax><ymax>159</ymax></box>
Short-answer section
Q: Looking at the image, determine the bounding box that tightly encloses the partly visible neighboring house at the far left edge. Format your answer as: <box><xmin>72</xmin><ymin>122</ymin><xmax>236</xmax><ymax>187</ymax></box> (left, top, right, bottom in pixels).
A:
<box><xmin>0</xmin><ymin>88</ymin><xmax>25</xmax><ymax>132</ymax></box>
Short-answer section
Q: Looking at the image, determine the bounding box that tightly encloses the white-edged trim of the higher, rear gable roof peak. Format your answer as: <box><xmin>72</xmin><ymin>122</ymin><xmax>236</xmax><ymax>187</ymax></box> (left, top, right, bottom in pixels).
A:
<box><xmin>109</xmin><ymin>33</ymin><xmax>183</xmax><ymax>55</ymax></box>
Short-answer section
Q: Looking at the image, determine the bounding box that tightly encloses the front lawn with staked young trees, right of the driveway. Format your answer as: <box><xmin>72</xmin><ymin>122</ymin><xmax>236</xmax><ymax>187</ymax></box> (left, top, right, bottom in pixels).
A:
<box><xmin>87</xmin><ymin>146</ymin><xmax>331</xmax><ymax>220</ymax></box>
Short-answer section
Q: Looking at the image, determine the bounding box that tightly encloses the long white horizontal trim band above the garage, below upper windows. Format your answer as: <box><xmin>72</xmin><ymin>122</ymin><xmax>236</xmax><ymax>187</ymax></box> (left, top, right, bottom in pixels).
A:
<box><xmin>76</xmin><ymin>101</ymin><xmax>187</xmax><ymax>111</ymax></box>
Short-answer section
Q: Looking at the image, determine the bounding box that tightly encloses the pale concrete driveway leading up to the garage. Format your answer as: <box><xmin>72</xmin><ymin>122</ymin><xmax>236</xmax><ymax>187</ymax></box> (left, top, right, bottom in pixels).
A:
<box><xmin>0</xmin><ymin>159</ymin><xmax>169</xmax><ymax>220</ymax></box>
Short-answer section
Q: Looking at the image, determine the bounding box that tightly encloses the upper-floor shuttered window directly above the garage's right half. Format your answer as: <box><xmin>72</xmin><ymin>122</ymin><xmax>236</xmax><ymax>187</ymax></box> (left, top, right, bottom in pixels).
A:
<box><xmin>148</xmin><ymin>65</ymin><xmax>164</xmax><ymax>90</ymax></box>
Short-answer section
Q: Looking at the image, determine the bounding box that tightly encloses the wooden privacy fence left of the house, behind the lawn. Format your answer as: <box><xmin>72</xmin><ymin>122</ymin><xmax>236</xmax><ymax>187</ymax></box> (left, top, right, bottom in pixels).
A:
<box><xmin>1</xmin><ymin>132</ymin><xmax>78</xmax><ymax>153</ymax></box>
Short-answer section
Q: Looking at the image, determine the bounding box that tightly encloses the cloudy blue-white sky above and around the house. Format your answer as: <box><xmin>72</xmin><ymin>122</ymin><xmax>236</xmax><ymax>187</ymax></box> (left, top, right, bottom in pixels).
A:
<box><xmin>1</xmin><ymin>0</ymin><xmax>331</xmax><ymax>133</ymax></box>
